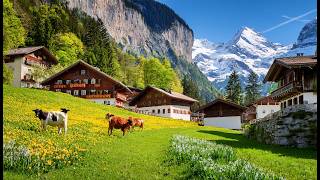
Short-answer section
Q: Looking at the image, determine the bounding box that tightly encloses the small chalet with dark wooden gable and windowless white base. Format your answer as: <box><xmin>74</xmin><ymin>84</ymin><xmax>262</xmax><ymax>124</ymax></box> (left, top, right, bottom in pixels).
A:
<box><xmin>196</xmin><ymin>98</ymin><xmax>246</xmax><ymax>129</ymax></box>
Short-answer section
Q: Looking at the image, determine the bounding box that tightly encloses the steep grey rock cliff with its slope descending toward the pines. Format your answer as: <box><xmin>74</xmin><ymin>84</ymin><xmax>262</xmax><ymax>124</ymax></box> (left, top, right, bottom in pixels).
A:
<box><xmin>67</xmin><ymin>0</ymin><xmax>217</xmax><ymax>101</ymax></box>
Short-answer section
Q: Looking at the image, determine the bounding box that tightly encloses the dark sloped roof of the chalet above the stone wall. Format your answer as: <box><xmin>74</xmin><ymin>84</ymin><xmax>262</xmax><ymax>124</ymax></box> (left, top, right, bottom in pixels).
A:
<box><xmin>263</xmin><ymin>56</ymin><xmax>317</xmax><ymax>83</ymax></box>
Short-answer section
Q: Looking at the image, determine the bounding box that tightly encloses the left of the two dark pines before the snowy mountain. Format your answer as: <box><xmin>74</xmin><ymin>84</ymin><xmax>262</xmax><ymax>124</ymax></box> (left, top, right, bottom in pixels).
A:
<box><xmin>226</xmin><ymin>71</ymin><xmax>242</xmax><ymax>104</ymax></box>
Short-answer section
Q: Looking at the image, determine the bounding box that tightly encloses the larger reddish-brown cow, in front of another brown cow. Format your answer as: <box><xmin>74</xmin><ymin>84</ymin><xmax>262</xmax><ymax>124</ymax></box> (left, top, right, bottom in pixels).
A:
<box><xmin>106</xmin><ymin>113</ymin><xmax>132</xmax><ymax>136</ymax></box>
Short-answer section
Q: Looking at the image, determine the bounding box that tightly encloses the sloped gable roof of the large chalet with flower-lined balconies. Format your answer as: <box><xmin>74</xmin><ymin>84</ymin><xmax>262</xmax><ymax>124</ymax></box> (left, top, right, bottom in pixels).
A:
<box><xmin>41</xmin><ymin>60</ymin><xmax>132</xmax><ymax>93</ymax></box>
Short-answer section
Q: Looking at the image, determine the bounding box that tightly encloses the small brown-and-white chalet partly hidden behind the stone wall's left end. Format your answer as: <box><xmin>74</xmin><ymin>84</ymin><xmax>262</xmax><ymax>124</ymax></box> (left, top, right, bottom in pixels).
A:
<box><xmin>242</xmin><ymin>96</ymin><xmax>280</xmax><ymax>122</ymax></box>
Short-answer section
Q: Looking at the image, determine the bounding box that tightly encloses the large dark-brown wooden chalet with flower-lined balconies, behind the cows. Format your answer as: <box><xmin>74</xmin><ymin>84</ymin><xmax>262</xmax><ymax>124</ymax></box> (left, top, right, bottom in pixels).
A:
<box><xmin>41</xmin><ymin>60</ymin><xmax>132</xmax><ymax>107</ymax></box>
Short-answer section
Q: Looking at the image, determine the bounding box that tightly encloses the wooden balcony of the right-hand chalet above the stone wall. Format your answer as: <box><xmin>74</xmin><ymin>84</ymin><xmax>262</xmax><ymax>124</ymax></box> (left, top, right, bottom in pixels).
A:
<box><xmin>271</xmin><ymin>81</ymin><xmax>302</xmax><ymax>99</ymax></box>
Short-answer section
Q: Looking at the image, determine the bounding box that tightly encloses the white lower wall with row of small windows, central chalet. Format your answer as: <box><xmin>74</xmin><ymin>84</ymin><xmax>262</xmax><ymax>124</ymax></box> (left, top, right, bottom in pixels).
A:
<box><xmin>132</xmin><ymin>105</ymin><xmax>190</xmax><ymax>121</ymax></box>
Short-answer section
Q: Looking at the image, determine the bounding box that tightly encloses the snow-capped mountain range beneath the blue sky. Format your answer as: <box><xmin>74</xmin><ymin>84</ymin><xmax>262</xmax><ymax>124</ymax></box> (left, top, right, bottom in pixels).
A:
<box><xmin>192</xmin><ymin>20</ymin><xmax>317</xmax><ymax>95</ymax></box>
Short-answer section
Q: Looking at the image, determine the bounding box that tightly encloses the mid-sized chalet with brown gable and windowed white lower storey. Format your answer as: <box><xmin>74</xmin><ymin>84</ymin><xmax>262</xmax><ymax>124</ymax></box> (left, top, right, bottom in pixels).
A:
<box><xmin>129</xmin><ymin>86</ymin><xmax>197</xmax><ymax>121</ymax></box>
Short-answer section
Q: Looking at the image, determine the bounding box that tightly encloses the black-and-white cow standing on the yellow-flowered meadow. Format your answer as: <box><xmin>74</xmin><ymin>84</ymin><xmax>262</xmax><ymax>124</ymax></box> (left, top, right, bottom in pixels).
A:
<box><xmin>32</xmin><ymin>108</ymin><xmax>70</xmax><ymax>134</ymax></box>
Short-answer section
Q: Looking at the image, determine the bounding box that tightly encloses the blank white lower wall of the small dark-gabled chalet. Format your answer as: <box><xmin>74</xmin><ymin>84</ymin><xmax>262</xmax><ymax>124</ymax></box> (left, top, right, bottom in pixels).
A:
<box><xmin>203</xmin><ymin>116</ymin><xmax>241</xmax><ymax>129</ymax></box>
